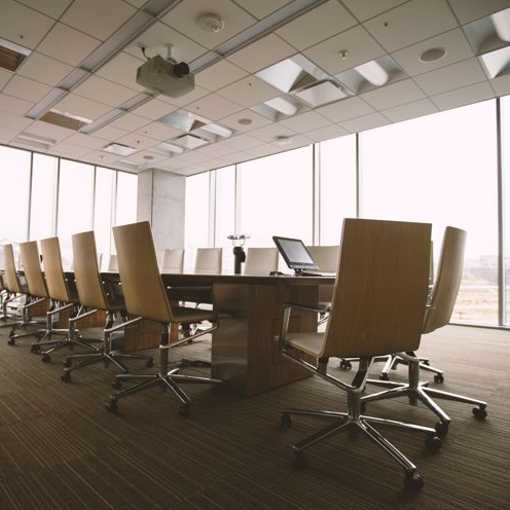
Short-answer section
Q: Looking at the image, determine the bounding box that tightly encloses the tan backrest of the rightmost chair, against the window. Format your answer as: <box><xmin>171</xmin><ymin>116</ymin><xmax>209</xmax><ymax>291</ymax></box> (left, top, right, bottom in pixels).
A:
<box><xmin>423</xmin><ymin>227</ymin><xmax>467</xmax><ymax>333</ymax></box>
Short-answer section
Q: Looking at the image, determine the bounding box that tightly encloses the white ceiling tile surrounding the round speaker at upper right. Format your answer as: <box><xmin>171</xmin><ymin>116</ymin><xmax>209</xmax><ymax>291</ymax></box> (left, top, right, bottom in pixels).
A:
<box><xmin>391</xmin><ymin>28</ymin><xmax>473</xmax><ymax>76</ymax></box>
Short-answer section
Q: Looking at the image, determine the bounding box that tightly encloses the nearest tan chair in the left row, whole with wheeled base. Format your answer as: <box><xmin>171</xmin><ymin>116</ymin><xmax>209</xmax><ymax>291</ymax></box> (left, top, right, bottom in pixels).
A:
<box><xmin>107</xmin><ymin>222</ymin><xmax>221</xmax><ymax>415</ymax></box>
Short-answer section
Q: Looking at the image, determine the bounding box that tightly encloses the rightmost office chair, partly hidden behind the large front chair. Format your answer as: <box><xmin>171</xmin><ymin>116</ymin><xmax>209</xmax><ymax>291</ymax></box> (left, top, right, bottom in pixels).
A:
<box><xmin>361</xmin><ymin>227</ymin><xmax>487</xmax><ymax>435</ymax></box>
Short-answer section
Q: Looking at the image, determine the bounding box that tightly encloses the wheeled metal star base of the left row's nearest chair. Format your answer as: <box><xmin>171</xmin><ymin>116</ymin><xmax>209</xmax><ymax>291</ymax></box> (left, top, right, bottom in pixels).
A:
<box><xmin>105</xmin><ymin>367</ymin><xmax>223</xmax><ymax>416</ymax></box>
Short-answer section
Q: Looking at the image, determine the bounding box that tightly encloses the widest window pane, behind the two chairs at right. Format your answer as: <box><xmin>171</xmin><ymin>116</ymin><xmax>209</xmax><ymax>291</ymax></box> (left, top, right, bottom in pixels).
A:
<box><xmin>359</xmin><ymin>101</ymin><xmax>498</xmax><ymax>324</ymax></box>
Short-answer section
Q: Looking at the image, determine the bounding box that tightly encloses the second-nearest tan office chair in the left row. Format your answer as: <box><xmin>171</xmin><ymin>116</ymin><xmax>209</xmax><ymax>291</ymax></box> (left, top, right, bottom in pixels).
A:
<box><xmin>61</xmin><ymin>232</ymin><xmax>153</xmax><ymax>382</ymax></box>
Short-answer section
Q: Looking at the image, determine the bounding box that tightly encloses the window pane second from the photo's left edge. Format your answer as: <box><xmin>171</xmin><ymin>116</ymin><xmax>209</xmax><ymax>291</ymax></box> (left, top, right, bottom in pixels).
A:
<box><xmin>30</xmin><ymin>154</ymin><xmax>58</xmax><ymax>240</ymax></box>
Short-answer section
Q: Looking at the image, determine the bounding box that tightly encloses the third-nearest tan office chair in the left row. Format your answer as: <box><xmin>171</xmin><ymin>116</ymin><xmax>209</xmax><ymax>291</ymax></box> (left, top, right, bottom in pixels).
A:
<box><xmin>32</xmin><ymin>237</ymin><xmax>98</xmax><ymax>362</ymax></box>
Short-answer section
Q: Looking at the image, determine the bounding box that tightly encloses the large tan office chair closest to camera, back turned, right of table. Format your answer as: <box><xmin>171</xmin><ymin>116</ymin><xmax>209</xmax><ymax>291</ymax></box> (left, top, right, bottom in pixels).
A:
<box><xmin>280</xmin><ymin>219</ymin><xmax>441</xmax><ymax>489</ymax></box>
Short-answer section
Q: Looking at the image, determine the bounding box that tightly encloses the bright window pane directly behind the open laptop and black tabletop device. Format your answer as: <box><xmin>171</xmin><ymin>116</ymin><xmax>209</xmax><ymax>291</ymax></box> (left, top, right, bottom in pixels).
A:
<box><xmin>237</xmin><ymin>145</ymin><xmax>313</xmax><ymax>246</ymax></box>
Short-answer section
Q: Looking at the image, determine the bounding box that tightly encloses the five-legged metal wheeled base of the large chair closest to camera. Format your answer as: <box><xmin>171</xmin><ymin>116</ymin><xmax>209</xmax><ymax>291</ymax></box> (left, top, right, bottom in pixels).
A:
<box><xmin>281</xmin><ymin>409</ymin><xmax>441</xmax><ymax>490</ymax></box>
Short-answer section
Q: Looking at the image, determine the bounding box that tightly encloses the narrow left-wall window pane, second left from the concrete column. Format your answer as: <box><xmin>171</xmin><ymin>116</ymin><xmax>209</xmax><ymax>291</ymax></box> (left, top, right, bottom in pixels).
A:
<box><xmin>94</xmin><ymin>167</ymin><xmax>116</xmax><ymax>260</ymax></box>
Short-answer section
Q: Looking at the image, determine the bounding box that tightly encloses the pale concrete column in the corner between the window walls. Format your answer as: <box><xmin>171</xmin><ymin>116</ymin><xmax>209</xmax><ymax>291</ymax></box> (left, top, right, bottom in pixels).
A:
<box><xmin>137</xmin><ymin>169</ymin><xmax>186</xmax><ymax>250</ymax></box>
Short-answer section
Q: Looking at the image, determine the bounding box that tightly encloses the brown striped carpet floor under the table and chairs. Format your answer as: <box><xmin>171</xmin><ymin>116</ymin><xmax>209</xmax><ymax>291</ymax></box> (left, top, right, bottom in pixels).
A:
<box><xmin>0</xmin><ymin>326</ymin><xmax>510</xmax><ymax>510</ymax></box>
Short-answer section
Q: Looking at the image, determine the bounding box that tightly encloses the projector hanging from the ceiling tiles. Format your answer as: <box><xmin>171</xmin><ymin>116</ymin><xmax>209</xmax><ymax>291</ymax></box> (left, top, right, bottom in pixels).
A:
<box><xmin>136</xmin><ymin>55</ymin><xmax>195</xmax><ymax>97</ymax></box>
